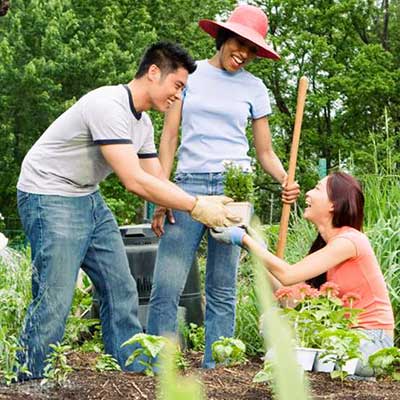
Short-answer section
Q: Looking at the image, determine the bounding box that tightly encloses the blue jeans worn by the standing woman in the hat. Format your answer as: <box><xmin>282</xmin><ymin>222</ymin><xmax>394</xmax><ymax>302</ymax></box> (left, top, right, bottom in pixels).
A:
<box><xmin>147</xmin><ymin>173</ymin><xmax>240</xmax><ymax>368</ymax></box>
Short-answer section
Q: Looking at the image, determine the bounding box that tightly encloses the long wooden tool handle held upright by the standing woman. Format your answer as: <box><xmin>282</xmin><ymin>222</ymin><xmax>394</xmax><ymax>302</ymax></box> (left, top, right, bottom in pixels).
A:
<box><xmin>276</xmin><ymin>76</ymin><xmax>308</xmax><ymax>258</ymax></box>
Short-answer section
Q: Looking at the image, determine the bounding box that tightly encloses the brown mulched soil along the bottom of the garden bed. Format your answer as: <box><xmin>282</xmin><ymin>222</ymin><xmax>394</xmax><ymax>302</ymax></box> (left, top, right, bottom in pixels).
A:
<box><xmin>0</xmin><ymin>353</ymin><xmax>400</xmax><ymax>400</ymax></box>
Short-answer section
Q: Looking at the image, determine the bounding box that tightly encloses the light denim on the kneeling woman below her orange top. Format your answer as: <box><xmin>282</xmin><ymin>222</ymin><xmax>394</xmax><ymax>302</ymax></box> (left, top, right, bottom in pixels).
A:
<box><xmin>355</xmin><ymin>329</ymin><xmax>393</xmax><ymax>377</ymax></box>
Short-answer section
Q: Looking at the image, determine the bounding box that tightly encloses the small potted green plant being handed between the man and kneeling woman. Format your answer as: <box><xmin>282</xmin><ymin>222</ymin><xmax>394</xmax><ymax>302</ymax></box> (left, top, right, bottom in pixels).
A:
<box><xmin>224</xmin><ymin>161</ymin><xmax>254</xmax><ymax>226</ymax></box>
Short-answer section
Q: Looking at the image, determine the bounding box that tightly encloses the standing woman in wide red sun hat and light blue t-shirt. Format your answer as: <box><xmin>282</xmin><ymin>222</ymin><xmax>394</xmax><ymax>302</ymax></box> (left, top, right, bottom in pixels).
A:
<box><xmin>147</xmin><ymin>5</ymin><xmax>299</xmax><ymax>368</ymax></box>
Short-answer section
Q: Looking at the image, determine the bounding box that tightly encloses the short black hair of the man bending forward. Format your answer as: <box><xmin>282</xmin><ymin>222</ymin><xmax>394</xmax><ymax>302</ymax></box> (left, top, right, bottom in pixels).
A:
<box><xmin>135</xmin><ymin>42</ymin><xmax>196</xmax><ymax>79</ymax></box>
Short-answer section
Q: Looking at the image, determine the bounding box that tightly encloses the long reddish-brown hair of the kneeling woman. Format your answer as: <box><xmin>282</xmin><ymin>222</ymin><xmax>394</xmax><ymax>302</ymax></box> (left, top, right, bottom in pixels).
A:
<box><xmin>307</xmin><ymin>172</ymin><xmax>364</xmax><ymax>288</ymax></box>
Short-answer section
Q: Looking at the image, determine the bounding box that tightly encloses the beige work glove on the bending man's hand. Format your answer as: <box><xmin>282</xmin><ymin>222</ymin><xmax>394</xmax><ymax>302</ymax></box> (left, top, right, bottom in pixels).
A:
<box><xmin>190</xmin><ymin>196</ymin><xmax>241</xmax><ymax>228</ymax></box>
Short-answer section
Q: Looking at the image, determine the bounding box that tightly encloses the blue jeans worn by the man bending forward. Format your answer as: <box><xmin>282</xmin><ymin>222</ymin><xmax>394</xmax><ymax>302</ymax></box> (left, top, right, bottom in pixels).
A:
<box><xmin>18</xmin><ymin>191</ymin><xmax>142</xmax><ymax>379</ymax></box>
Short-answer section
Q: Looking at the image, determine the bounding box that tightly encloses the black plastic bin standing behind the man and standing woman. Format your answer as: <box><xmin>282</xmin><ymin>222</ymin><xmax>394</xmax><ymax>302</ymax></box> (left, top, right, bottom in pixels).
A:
<box><xmin>92</xmin><ymin>224</ymin><xmax>204</xmax><ymax>330</ymax></box>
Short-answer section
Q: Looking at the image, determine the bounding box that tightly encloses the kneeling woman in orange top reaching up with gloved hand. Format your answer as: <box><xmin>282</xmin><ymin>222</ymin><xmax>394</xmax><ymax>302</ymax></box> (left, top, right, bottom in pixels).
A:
<box><xmin>211</xmin><ymin>172</ymin><xmax>394</xmax><ymax>376</ymax></box>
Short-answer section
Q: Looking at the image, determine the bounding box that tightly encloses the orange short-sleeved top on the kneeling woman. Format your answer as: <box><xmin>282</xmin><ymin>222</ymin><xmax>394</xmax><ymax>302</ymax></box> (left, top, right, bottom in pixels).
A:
<box><xmin>327</xmin><ymin>226</ymin><xmax>394</xmax><ymax>330</ymax></box>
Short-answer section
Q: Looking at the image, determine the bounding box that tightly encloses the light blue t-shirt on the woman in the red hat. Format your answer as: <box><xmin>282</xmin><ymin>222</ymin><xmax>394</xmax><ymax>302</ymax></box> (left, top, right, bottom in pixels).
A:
<box><xmin>177</xmin><ymin>60</ymin><xmax>271</xmax><ymax>173</ymax></box>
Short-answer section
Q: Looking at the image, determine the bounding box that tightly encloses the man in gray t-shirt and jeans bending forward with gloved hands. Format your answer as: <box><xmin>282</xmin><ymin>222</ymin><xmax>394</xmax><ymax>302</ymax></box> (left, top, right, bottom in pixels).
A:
<box><xmin>17</xmin><ymin>43</ymin><xmax>237</xmax><ymax>380</ymax></box>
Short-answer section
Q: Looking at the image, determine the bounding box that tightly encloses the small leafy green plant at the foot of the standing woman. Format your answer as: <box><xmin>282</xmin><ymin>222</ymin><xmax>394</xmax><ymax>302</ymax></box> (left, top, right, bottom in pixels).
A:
<box><xmin>211</xmin><ymin>336</ymin><xmax>246</xmax><ymax>366</ymax></box>
